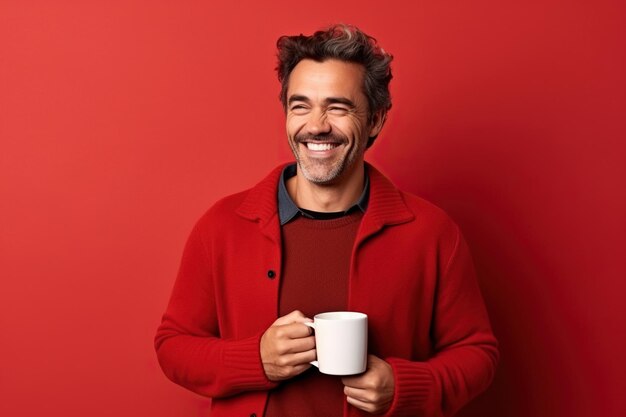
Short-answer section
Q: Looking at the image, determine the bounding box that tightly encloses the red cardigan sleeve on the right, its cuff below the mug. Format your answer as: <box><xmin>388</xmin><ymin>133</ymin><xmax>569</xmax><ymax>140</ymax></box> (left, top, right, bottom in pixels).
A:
<box><xmin>386</xmin><ymin>228</ymin><xmax>499</xmax><ymax>416</ymax></box>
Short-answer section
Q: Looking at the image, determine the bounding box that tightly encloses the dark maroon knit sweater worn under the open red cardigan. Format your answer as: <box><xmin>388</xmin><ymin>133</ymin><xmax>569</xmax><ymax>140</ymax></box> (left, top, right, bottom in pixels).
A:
<box><xmin>265</xmin><ymin>210</ymin><xmax>363</xmax><ymax>417</ymax></box>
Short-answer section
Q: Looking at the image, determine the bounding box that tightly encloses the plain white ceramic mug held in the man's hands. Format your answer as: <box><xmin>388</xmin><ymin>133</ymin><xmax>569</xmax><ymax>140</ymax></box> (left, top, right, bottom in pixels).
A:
<box><xmin>304</xmin><ymin>311</ymin><xmax>367</xmax><ymax>375</ymax></box>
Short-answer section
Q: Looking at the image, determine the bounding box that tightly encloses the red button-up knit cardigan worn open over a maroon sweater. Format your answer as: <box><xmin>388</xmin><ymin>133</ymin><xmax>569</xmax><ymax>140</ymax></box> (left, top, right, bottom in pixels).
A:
<box><xmin>155</xmin><ymin>166</ymin><xmax>498</xmax><ymax>417</ymax></box>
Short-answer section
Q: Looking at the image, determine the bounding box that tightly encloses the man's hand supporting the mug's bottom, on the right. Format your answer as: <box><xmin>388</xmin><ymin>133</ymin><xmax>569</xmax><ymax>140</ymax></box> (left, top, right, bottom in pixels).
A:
<box><xmin>341</xmin><ymin>355</ymin><xmax>395</xmax><ymax>414</ymax></box>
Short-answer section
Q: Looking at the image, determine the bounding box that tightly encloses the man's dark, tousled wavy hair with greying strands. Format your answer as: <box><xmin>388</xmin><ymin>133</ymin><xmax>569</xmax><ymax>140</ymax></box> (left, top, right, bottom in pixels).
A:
<box><xmin>276</xmin><ymin>24</ymin><xmax>393</xmax><ymax>148</ymax></box>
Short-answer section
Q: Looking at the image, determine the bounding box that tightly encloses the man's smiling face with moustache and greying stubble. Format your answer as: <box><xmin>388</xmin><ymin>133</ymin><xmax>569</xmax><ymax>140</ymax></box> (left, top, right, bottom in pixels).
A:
<box><xmin>287</xmin><ymin>59</ymin><xmax>382</xmax><ymax>185</ymax></box>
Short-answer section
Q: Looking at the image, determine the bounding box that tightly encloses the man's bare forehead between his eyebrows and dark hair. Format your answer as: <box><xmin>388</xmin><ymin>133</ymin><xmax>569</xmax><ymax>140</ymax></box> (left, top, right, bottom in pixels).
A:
<box><xmin>287</xmin><ymin>59</ymin><xmax>365</xmax><ymax>101</ymax></box>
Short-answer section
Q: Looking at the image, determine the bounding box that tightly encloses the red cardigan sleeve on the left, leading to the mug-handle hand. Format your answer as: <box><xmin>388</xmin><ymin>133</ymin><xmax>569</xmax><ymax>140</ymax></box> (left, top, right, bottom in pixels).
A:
<box><xmin>155</xmin><ymin>218</ymin><xmax>275</xmax><ymax>398</ymax></box>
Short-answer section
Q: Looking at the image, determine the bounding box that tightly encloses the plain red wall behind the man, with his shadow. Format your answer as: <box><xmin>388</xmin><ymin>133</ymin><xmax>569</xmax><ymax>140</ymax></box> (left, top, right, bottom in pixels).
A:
<box><xmin>0</xmin><ymin>0</ymin><xmax>626</xmax><ymax>417</ymax></box>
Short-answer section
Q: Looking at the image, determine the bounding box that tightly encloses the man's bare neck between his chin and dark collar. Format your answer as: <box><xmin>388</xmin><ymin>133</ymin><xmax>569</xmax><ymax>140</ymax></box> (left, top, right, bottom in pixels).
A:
<box><xmin>287</xmin><ymin>163</ymin><xmax>365</xmax><ymax>212</ymax></box>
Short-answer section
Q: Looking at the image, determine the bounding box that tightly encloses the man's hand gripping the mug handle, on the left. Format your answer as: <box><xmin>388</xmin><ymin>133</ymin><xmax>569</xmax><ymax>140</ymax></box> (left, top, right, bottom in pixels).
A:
<box><xmin>261</xmin><ymin>310</ymin><xmax>316</xmax><ymax>381</ymax></box>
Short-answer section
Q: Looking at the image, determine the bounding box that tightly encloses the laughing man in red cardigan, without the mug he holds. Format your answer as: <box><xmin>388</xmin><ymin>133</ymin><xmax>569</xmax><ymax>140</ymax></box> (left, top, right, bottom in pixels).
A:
<box><xmin>156</xmin><ymin>25</ymin><xmax>498</xmax><ymax>417</ymax></box>
